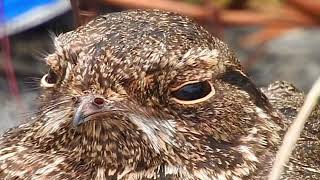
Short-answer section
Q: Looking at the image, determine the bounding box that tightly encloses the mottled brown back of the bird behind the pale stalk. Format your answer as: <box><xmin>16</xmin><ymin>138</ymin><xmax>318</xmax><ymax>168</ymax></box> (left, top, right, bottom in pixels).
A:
<box><xmin>262</xmin><ymin>81</ymin><xmax>320</xmax><ymax>179</ymax></box>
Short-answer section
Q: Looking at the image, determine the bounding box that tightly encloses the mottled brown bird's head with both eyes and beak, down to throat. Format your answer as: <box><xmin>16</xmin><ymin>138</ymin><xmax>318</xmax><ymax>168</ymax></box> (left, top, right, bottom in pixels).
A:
<box><xmin>35</xmin><ymin>11</ymin><xmax>279</xmax><ymax>179</ymax></box>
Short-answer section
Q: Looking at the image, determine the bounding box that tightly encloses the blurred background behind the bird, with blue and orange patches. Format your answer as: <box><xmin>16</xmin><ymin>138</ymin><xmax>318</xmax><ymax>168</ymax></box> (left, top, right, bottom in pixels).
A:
<box><xmin>0</xmin><ymin>0</ymin><xmax>320</xmax><ymax>133</ymax></box>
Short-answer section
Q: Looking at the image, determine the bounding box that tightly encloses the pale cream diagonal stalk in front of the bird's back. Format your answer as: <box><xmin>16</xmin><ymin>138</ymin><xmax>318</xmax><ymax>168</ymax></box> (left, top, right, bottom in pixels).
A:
<box><xmin>268</xmin><ymin>77</ymin><xmax>320</xmax><ymax>180</ymax></box>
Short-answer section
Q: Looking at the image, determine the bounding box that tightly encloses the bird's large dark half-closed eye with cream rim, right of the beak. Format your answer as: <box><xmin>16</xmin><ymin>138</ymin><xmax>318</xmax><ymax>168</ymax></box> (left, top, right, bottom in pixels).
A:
<box><xmin>171</xmin><ymin>81</ymin><xmax>215</xmax><ymax>104</ymax></box>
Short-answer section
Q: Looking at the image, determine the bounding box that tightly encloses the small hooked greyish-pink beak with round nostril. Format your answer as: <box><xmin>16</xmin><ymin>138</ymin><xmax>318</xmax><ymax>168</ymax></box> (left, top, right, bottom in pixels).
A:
<box><xmin>73</xmin><ymin>95</ymin><xmax>110</xmax><ymax>127</ymax></box>
